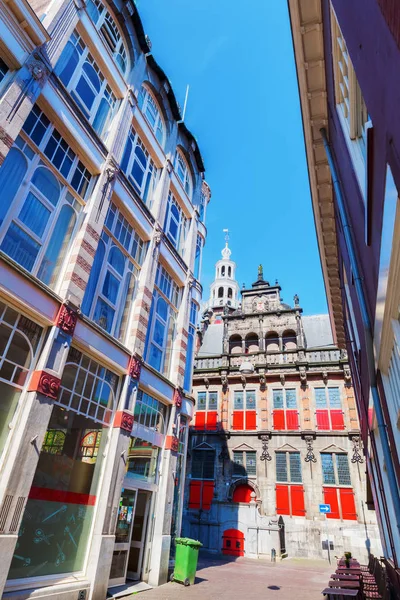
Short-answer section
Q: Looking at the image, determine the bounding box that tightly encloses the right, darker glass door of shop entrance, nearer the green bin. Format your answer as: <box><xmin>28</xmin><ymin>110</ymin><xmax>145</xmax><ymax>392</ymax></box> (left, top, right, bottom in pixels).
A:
<box><xmin>126</xmin><ymin>490</ymin><xmax>151</xmax><ymax>580</ymax></box>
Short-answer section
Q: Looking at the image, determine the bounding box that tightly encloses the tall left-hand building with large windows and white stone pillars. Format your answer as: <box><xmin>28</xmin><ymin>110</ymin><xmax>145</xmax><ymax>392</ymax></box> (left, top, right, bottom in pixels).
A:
<box><xmin>0</xmin><ymin>0</ymin><xmax>210</xmax><ymax>600</ymax></box>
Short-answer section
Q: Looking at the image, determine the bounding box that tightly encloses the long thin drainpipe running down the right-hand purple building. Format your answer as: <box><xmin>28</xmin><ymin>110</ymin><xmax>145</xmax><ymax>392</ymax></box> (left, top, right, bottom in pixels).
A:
<box><xmin>320</xmin><ymin>127</ymin><xmax>400</xmax><ymax>534</ymax></box>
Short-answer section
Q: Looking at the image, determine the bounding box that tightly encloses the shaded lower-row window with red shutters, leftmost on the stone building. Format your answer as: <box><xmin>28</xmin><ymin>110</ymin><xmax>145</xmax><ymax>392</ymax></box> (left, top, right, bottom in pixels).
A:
<box><xmin>189</xmin><ymin>449</ymin><xmax>215</xmax><ymax>510</ymax></box>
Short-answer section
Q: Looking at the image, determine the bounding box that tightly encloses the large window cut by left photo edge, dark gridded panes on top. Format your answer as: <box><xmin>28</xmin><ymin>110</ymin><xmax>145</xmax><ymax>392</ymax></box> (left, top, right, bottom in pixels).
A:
<box><xmin>0</xmin><ymin>113</ymin><xmax>91</xmax><ymax>288</ymax></box>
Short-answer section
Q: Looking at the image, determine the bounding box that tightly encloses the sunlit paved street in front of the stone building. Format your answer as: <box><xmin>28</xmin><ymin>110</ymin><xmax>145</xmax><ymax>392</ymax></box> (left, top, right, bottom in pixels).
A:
<box><xmin>139</xmin><ymin>557</ymin><xmax>335</xmax><ymax>600</ymax></box>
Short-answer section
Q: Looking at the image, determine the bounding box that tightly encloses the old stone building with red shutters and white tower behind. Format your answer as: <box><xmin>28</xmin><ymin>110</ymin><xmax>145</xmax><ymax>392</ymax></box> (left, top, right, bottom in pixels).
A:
<box><xmin>183</xmin><ymin>243</ymin><xmax>380</xmax><ymax>559</ymax></box>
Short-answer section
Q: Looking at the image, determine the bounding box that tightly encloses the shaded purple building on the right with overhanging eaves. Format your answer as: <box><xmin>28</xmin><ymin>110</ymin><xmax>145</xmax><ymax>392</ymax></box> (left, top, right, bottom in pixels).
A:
<box><xmin>288</xmin><ymin>0</ymin><xmax>400</xmax><ymax>568</ymax></box>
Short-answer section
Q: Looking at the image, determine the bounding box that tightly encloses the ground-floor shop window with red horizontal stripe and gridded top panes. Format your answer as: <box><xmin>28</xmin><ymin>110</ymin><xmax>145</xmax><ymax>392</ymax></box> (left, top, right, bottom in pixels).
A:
<box><xmin>9</xmin><ymin>348</ymin><xmax>118</xmax><ymax>579</ymax></box>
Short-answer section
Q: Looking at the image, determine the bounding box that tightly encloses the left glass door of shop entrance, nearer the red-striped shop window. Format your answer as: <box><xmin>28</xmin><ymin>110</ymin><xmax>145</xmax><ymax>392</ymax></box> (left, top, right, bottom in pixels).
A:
<box><xmin>109</xmin><ymin>489</ymin><xmax>138</xmax><ymax>587</ymax></box>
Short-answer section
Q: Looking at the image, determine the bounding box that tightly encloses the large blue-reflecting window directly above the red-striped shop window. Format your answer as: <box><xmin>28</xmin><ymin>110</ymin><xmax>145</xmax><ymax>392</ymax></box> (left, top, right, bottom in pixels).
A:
<box><xmin>82</xmin><ymin>203</ymin><xmax>147</xmax><ymax>341</ymax></box>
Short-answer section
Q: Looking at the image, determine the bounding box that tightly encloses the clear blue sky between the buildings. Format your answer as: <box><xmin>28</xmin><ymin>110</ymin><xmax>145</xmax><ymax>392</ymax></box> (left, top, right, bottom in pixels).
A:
<box><xmin>137</xmin><ymin>0</ymin><xmax>327</xmax><ymax>314</ymax></box>
